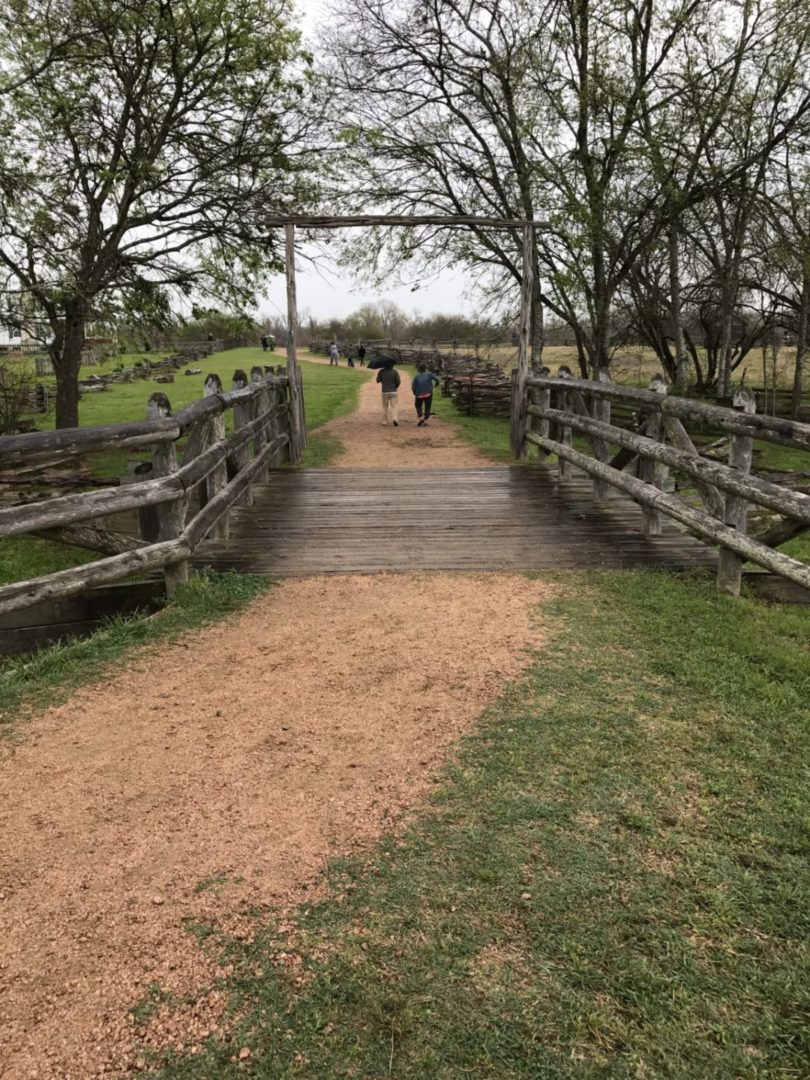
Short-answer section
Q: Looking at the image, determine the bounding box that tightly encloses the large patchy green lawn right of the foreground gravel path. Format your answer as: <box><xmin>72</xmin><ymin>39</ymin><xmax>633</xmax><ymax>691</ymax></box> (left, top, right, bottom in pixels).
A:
<box><xmin>142</xmin><ymin>572</ymin><xmax>810</xmax><ymax>1080</ymax></box>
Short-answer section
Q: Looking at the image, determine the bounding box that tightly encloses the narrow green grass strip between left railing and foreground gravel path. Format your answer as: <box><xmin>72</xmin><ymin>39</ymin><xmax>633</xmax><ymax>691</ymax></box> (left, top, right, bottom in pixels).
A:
<box><xmin>0</xmin><ymin>572</ymin><xmax>270</xmax><ymax>730</ymax></box>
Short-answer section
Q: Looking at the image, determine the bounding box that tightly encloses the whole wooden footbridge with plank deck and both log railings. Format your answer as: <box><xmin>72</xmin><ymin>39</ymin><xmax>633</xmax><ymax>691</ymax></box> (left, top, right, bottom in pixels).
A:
<box><xmin>0</xmin><ymin>359</ymin><xmax>810</xmax><ymax>648</ymax></box>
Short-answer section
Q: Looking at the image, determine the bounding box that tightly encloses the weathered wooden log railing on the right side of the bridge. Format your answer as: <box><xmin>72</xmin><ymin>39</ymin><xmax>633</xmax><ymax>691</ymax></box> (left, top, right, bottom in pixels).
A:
<box><xmin>511</xmin><ymin>369</ymin><xmax>810</xmax><ymax>594</ymax></box>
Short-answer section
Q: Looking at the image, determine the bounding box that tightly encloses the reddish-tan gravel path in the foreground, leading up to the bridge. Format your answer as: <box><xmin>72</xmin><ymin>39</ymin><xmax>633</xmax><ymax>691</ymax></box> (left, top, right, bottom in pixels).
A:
<box><xmin>0</xmin><ymin>570</ymin><xmax>552</xmax><ymax>1080</ymax></box>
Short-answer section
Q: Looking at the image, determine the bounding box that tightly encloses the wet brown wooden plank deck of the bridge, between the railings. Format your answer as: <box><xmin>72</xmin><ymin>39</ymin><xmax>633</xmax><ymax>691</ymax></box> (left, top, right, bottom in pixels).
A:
<box><xmin>194</xmin><ymin>465</ymin><xmax>715</xmax><ymax>577</ymax></box>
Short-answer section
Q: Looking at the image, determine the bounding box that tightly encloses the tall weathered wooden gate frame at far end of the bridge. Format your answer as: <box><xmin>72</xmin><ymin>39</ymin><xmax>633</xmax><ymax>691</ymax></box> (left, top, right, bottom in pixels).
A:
<box><xmin>265</xmin><ymin>214</ymin><xmax>539</xmax><ymax>460</ymax></box>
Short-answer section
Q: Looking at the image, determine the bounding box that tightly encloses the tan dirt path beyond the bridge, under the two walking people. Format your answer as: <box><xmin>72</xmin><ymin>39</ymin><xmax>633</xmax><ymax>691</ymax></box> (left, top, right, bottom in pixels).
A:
<box><xmin>319</xmin><ymin>362</ymin><xmax>492</xmax><ymax>469</ymax></box>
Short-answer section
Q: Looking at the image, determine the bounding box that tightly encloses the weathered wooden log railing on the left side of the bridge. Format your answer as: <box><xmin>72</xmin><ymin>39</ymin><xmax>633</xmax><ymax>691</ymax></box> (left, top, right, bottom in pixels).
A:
<box><xmin>0</xmin><ymin>366</ymin><xmax>306</xmax><ymax>612</ymax></box>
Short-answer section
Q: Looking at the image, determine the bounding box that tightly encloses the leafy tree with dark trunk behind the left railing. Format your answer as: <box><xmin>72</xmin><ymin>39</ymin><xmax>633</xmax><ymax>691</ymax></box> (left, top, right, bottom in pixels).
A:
<box><xmin>0</xmin><ymin>0</ymin><xmax>315</xmax><ymax>427</ymax></box>
